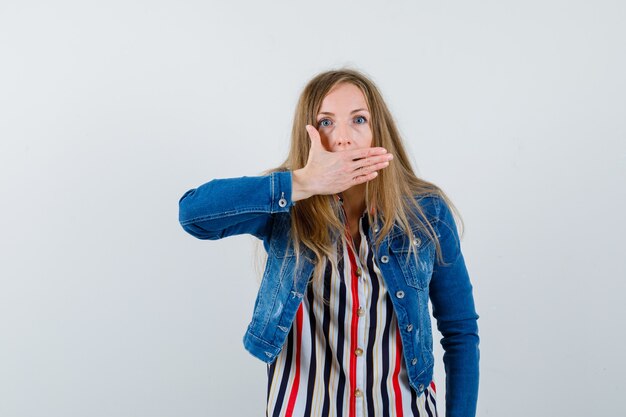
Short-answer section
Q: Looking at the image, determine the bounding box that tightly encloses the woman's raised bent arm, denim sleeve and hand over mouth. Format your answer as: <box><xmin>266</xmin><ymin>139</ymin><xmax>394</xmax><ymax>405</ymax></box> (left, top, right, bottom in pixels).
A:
<box><xmin>179</xmin><ymin>125</ymin><xmax>393</xmax><ymax>240</ymax></box>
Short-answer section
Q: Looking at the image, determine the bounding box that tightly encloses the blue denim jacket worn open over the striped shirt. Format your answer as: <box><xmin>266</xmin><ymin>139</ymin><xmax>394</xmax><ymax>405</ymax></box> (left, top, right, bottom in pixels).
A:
<box><xmin>179</xmin><ymin>171</ymin><xmax>479</xmax><ymax>417</ymax></box>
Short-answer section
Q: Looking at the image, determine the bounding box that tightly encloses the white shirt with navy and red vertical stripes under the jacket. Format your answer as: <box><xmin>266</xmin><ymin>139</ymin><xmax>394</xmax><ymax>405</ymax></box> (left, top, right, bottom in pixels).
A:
<box><xmin>266</xmin><ymin>200</ymin><xmax>437</xmax><ymax>417</ymax></box>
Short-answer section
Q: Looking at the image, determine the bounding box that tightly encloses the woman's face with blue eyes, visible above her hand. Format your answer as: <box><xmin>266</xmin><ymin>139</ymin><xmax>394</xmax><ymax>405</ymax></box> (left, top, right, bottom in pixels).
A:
<box><xmin>316</xmin><ymin>83</ymin><xmax>372</xmax><ymax>152</ymax></box>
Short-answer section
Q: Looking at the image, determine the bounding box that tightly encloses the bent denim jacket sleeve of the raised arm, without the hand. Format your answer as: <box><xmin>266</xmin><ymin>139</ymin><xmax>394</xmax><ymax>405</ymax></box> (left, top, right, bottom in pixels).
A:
<box><xmin>178</xmin><ymin>171</ymin><xmax>294</xmax><ymax>240</ymax></box>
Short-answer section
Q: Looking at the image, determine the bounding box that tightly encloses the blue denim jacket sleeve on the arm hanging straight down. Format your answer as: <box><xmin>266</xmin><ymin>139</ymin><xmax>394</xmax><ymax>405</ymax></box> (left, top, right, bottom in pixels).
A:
<box><xmin>429</xmin><ymin>199</ymin><xmax>480</xmax><ymax>417</ymax></box>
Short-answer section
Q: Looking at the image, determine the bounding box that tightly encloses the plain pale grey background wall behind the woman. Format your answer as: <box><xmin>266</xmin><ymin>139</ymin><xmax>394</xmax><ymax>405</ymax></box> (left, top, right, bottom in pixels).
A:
<box><xmin>0</xmin><ymin>0</ymin><xmax>626</xmax><ymax>417</ymax></box>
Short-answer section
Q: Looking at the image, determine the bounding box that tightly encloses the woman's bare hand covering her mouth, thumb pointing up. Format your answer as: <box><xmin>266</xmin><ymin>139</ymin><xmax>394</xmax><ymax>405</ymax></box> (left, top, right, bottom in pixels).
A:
<box><xmin>291</xmin><ymin>125</ymin><xmax>393</xmax><ymax>201</ymax></box>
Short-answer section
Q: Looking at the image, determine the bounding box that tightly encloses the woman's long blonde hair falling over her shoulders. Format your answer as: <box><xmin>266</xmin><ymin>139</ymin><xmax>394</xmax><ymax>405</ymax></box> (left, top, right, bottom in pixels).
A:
<box><xmin>265</xmin><ymin>69</ymin><xmax>462</xmax><ymax>279</ymax></box>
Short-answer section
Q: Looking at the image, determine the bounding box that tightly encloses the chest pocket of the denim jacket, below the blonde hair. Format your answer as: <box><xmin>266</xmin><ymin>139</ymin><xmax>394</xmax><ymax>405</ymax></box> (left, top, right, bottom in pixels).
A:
<box><xmin>389</xmin><ymin>230</ymin><xmax>435</xmax><ymax>289</ymax></box>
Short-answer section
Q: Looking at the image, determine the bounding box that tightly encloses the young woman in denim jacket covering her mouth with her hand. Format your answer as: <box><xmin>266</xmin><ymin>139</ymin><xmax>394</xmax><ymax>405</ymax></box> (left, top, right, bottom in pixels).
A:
<box><xmin>179</xmin><ymin>70</ymin><xmax>479</xmax><ymax>417</ymax></box>
